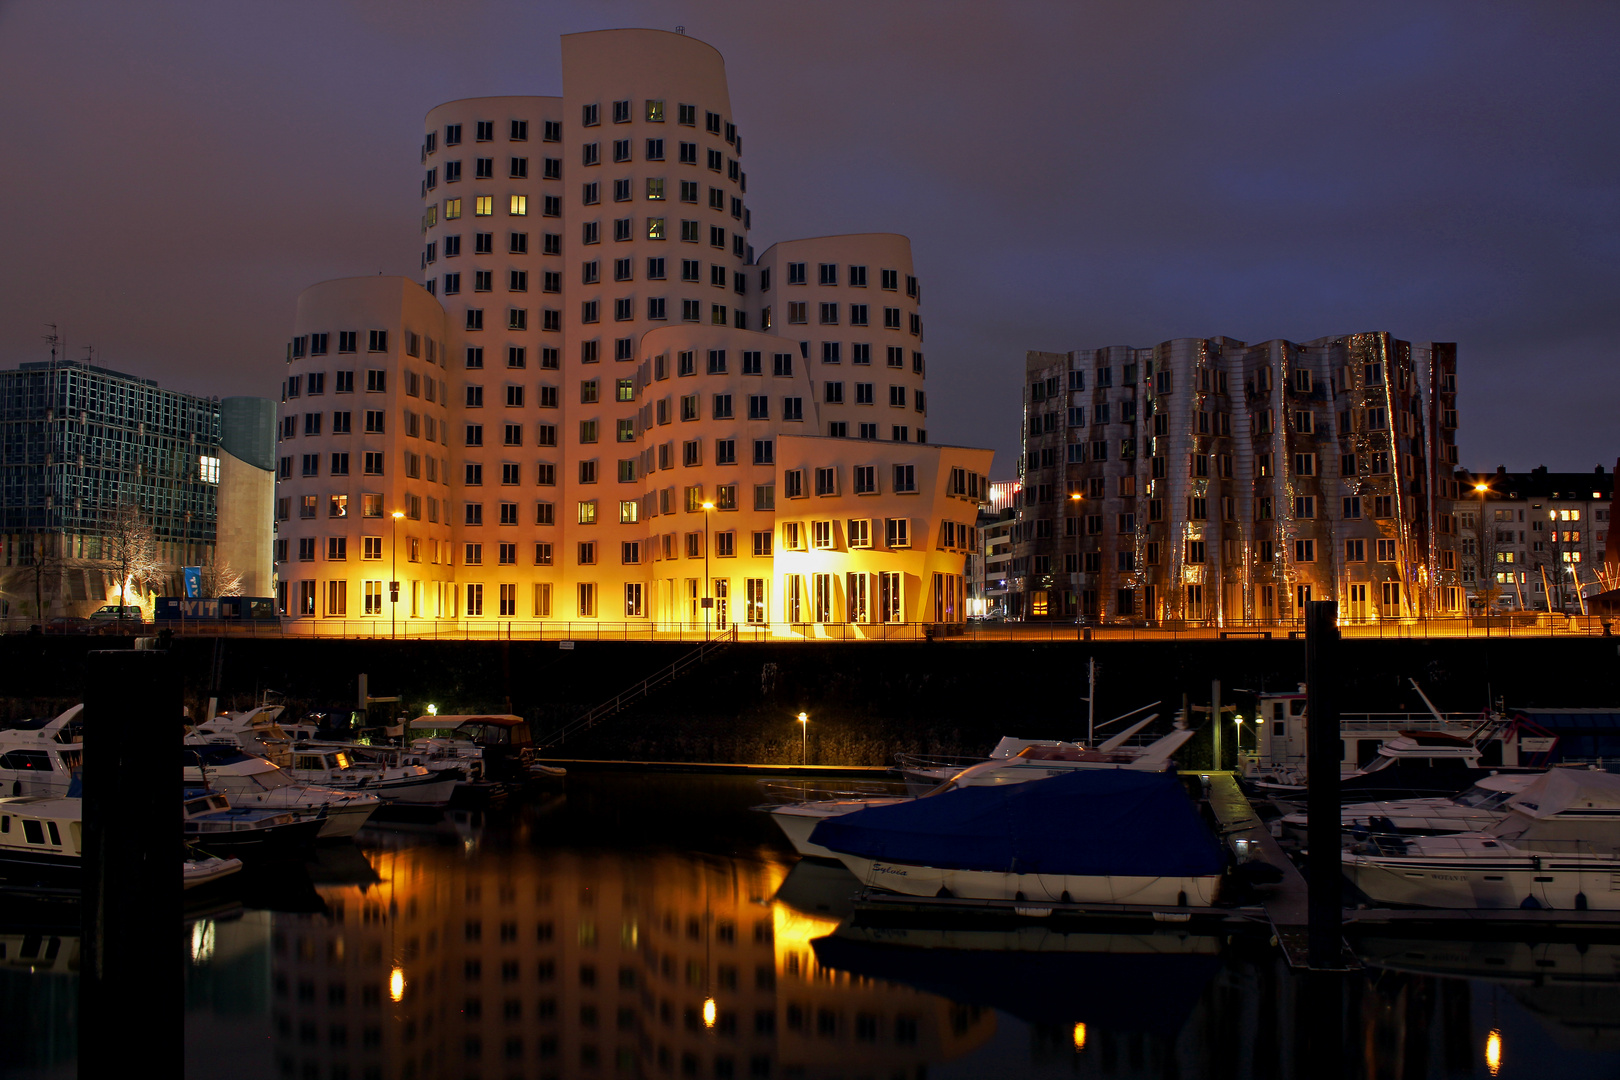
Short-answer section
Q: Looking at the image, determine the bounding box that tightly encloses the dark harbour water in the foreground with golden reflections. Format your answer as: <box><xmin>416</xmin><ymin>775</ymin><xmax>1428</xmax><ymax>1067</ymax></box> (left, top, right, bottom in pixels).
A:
<box><xmin>0</xmin><ymin>776</ymin><xmax>1620</xmax><ymax>1080</ymax></box>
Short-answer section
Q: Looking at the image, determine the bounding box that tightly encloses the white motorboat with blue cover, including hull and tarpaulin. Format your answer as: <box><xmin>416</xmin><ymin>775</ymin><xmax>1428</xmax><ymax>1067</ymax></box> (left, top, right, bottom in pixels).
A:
<box><xmin>810</xmin><ymin>769</ymin><xmax>1226</xmax><ymax>907</ymax></box>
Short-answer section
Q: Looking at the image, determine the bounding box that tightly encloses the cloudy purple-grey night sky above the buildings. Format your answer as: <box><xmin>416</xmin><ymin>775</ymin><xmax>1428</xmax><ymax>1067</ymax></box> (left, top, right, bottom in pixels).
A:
<box><xmin>0</xmin><ymin>0</ymin><xmax>1620</xmax><ymax>476</ymax></box>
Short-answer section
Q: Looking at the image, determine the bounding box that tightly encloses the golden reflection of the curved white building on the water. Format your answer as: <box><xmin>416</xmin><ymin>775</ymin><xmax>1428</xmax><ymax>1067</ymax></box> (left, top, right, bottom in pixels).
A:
<box><xmin>251</xmin><ymin>845</ymin><xmax>995</xmax><ymax>1080</ymax></box>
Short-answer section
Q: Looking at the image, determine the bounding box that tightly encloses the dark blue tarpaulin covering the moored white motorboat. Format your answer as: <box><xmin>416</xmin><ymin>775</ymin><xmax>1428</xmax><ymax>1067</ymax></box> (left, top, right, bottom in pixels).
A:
<box><xmin>810</xmin><ymin>769</ymin><xmax>1226</xmax><ymax>878</ymax></box>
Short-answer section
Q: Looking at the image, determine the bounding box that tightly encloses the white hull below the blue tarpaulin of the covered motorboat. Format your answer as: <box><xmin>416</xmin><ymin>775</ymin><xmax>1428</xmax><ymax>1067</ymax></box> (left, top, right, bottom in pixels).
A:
<box><xmin>838</xmin><ymin>855</ymin><xmax>1220</xmax><ymax>907</ymax></box>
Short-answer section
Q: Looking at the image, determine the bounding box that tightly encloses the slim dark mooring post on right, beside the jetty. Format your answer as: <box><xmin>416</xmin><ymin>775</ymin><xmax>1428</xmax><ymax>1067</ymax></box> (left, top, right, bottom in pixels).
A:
<box><xmin>1306</xmin><ymin>601</ymin><xmax>1345</xmax><ymax>968</ymax></box>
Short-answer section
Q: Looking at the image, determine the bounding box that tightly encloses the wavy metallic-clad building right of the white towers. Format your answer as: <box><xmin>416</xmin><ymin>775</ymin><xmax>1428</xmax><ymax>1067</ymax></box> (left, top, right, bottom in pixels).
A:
<box><xmin>1009</xmin><ymin>334</ymin><xmax>1463</xmax><ymax>625</ymax></box>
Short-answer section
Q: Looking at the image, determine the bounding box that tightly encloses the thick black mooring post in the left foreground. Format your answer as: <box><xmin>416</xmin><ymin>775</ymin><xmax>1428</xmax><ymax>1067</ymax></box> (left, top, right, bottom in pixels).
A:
<box><xmin>79</xmin><ymin>649</ymin><xmax>185</xmax><ymax>1077</ymax></box>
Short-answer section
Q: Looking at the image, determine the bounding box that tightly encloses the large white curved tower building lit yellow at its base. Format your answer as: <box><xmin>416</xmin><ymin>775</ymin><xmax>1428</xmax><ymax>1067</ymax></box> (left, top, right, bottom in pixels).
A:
<box><xmin>277</xmin><ymin>29</ymin><xmax>991</xmax><ymax>635</ymax></box>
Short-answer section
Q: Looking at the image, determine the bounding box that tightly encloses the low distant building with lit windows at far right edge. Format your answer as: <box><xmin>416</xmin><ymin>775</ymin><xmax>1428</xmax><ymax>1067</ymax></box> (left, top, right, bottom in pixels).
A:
<box><xmin>1455</xmin><ymin>465</ymin><xmax>1615</xmax><ymax>614</ymax></box>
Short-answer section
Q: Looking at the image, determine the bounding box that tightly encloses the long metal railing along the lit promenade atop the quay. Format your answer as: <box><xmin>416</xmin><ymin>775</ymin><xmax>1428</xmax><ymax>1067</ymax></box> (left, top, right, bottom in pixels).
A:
<box><xmin>0</xmin><ymin>614</ymin><xmax>1620</xmax><ymax>643</ymax></box>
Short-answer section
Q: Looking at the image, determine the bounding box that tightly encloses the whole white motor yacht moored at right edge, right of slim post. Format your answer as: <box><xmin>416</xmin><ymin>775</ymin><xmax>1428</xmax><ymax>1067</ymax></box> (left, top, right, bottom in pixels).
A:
<box><xmin>1341</xmin><ymin>769</ymin><xmax>1620</xmax><ymax>912</ymax></box>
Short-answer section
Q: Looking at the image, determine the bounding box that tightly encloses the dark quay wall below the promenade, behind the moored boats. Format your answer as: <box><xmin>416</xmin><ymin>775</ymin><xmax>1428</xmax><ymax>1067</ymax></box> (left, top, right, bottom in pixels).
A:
<box><xmin>0</xmin><ymin>636</ymin><xmax>1620</xmax><ymax>767</ymax></box>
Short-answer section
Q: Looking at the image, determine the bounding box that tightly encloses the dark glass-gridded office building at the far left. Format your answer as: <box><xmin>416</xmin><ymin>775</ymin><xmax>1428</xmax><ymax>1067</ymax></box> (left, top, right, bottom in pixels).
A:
<box><xmin>0</xmin><ymin>359</ymin><xmax>274</xmax><ymax>620</ymax></box>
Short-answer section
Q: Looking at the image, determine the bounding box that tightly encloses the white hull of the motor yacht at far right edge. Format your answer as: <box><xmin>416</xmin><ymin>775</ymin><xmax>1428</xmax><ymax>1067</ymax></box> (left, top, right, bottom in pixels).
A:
<box><xmin>1341</xmin><ymin>852</ymin><xmax>1620</xmax><ymax>912</ymax></box>
